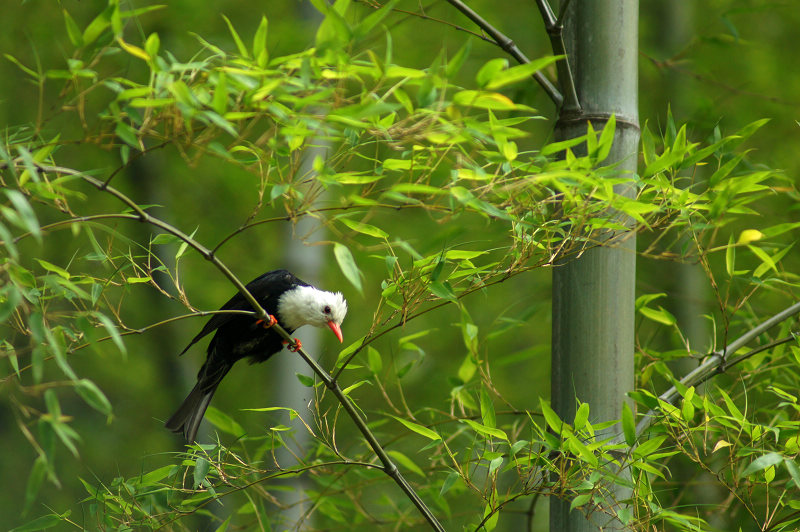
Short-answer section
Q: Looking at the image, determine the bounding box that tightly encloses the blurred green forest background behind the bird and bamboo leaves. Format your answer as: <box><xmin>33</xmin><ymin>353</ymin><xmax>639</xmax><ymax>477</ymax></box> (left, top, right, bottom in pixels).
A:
<box><xmin>0</xmin><ymin>1</ymin><xmax>800</xmax><ymax>530</ymax></box>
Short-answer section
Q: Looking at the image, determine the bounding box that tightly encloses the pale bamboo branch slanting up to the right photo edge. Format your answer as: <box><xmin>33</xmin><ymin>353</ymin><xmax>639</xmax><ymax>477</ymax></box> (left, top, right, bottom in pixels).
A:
<box><xmin>632</xmin><ymin>303</ymin><xmax>800</xmax><ymax>443</ymax></box>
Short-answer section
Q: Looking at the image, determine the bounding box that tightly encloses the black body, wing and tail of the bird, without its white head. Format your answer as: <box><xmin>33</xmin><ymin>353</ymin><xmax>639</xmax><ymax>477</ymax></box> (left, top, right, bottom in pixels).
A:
<box><xmin>165</xmin><ymin>270</ymin><xmax>309</xmax><ymax>442</ymax></box>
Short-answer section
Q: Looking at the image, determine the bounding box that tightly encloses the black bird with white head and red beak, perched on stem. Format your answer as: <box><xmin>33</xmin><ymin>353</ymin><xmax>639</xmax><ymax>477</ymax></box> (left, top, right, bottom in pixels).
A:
<box><xmin>164</xmin><ymin>270</ymin><xmax>347</xmax><ymax>443</ymax></box>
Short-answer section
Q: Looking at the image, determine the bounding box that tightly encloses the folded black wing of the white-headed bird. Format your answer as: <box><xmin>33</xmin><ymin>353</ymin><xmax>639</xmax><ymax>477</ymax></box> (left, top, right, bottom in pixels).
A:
<box><xmin>180</xmin><ymin>270</ymin><xmax>308</xmax><ymax>355</ymax></box>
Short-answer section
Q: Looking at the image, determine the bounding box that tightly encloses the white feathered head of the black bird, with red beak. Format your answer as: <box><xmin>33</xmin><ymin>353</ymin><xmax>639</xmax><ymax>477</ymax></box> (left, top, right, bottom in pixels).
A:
<box><xmin>278</xmin><ymin>286</ymin><xmax>347</xmax><ymax>342</ymax></box>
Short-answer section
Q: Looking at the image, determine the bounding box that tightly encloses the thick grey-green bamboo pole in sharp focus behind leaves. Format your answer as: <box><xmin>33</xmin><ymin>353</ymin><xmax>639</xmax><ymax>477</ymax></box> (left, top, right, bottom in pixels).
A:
<box><xmin>550</xmin><ymin>0</ymin><xmax>639</xmax><ymax>532</ymax></box>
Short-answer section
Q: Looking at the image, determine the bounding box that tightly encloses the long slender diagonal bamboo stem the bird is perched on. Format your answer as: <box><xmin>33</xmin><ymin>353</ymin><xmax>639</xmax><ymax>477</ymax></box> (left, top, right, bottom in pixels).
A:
<box><xmin>25</xmin><ymin>165</ymin><xmax>444</xmax><ymax>532</ymax></box>
